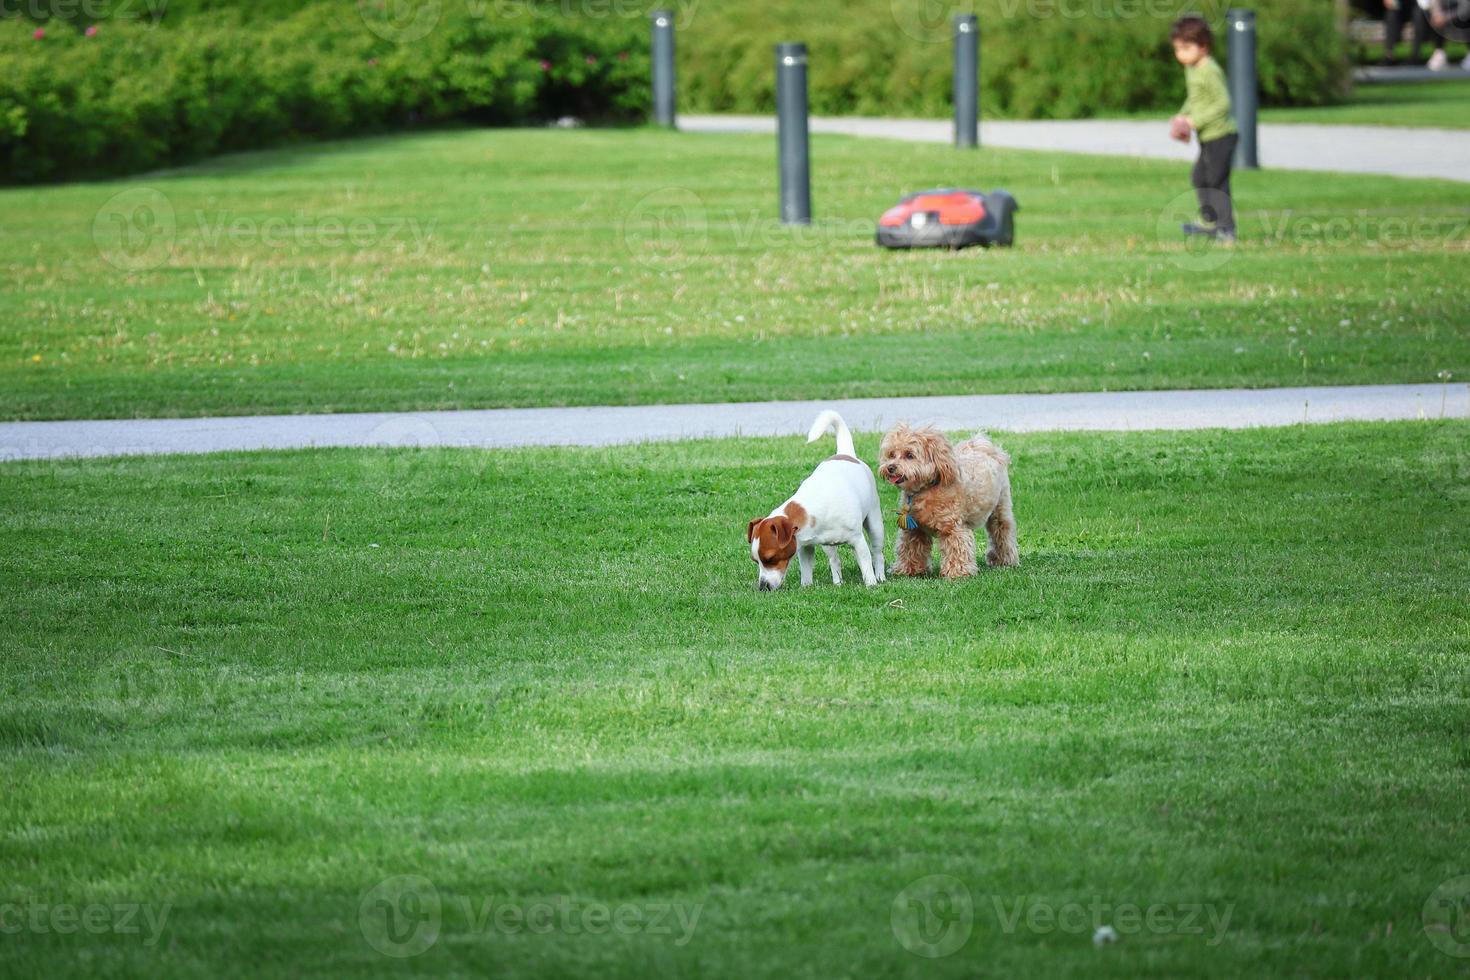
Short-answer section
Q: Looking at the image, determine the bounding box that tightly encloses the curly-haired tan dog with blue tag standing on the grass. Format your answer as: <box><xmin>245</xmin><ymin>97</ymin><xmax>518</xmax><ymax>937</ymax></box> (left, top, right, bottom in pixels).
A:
<box><xmin>878</xmin><ymin>425</ymin><xmax>1020</xmax><ymax>579</ymax></box>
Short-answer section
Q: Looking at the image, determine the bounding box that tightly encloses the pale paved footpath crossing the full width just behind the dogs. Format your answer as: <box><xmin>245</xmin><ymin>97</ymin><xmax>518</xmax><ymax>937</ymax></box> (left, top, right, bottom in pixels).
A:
<box><xmin>0</xmin><ymin>382</ymin><xmax>1470</xmax><ymax>460</ymax></box>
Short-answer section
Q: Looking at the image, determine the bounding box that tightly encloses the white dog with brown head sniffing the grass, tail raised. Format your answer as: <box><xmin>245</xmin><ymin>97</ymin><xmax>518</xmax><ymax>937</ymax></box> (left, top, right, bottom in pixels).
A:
<box><xmin>745</xmin><ymin>411</ymin><xmax>883</xmax><ymax>592</ymax></box>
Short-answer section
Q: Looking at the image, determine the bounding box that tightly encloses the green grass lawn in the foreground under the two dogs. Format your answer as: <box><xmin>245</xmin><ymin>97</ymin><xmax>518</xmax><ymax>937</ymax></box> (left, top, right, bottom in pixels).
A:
<box><xmin>0</xmin><ymin>417</ymin><xmax>1470</xmax><ymax>977</ymax></box>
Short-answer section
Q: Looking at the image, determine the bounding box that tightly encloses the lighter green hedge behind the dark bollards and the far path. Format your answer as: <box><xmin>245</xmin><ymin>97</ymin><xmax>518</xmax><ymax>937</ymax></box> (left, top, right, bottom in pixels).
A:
<box><xmin>682</xmin><ymin>0</ymin><xmax>1348</xmax><ymax>119</ymax></box>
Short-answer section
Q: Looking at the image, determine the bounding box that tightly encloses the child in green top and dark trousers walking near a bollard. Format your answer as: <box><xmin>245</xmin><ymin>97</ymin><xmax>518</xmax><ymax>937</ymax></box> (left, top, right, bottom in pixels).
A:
<box><xmin>1169</xmin><ymin>16</ymin><xmax>1239</xmax><ymax>244</ymax></box>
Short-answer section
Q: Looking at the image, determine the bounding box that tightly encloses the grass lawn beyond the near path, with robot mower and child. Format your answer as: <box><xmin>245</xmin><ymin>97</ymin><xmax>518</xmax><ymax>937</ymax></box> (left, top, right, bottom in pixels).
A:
<box><xmin>0</xmin><ymin>131</ymin><xmax>1470</xmax><ymax>419</ymax></box>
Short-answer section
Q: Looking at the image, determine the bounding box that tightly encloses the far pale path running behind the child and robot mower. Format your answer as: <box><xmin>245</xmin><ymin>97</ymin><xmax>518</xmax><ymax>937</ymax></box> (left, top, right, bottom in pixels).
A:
<box><xmin>679</xmin><ymin>116</ymin><xmax>1470</xmax><ymax>183</ymax></box>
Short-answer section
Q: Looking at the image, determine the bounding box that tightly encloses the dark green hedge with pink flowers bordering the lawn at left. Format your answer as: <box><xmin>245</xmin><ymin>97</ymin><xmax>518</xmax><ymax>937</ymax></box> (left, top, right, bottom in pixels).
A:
<box><xmin>0</xmin><ymin>3</ymin><xmax>650</xmax><ymax>182</ymax></box>
